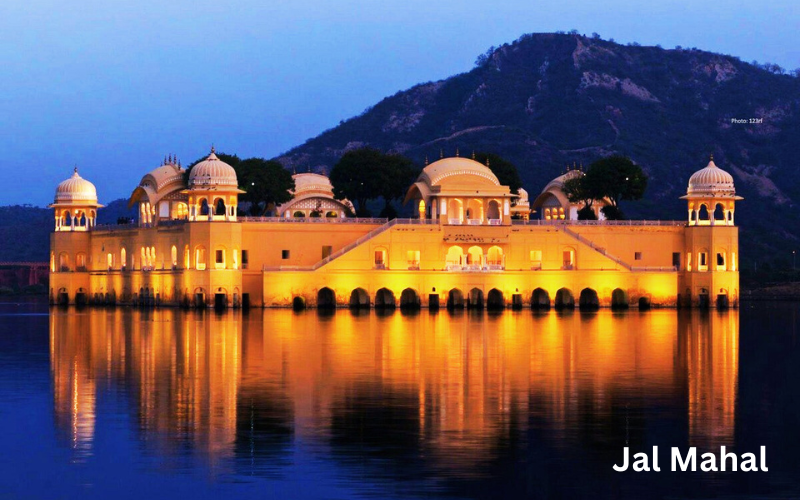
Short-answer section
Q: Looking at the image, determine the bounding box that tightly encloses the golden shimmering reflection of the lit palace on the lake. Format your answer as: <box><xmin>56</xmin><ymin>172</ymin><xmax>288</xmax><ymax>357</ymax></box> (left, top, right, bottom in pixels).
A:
<box><xmin>50</xmin><ymin>309</ymin><xmax>739</xmax><ymax>468</ymax></box>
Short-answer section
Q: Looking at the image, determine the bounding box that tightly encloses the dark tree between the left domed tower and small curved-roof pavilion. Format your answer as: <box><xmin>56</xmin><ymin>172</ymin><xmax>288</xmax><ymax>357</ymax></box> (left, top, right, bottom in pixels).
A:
<box><xmin>234</xmin><ymin>158</ymin><xmax>294</xmax><ymax>215</ymax></box>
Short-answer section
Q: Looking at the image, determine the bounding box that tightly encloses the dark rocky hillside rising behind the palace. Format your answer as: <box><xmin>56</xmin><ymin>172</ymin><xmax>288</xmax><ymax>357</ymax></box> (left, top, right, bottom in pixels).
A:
<box><xmin>279</xmin><ymin>34</ymin><xmax>800</xmax><ymax>265</ymax></box>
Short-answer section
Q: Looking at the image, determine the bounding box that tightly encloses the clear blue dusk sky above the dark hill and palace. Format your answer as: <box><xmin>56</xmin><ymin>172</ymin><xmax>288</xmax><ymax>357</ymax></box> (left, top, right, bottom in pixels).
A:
<box><xmin>0</xmin><ymin>0</ymin><xmax>800</xmax><ymax>205</ymax></box>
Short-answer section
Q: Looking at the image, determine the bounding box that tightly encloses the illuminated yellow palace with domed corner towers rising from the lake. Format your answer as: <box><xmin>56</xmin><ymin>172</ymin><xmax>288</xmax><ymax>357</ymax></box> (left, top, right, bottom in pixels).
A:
<box><xmin>50</xmin><ymin>149</ymin><xmax>741</xmax><ymax>309</ymax></box>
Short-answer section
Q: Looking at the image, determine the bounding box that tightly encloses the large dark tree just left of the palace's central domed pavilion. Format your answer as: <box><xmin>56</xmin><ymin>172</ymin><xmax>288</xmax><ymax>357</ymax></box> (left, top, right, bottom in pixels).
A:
<box><xmin>330</xmin><ymin>147</ymin><xmax>416</xmax><ymax>216</ymax></box>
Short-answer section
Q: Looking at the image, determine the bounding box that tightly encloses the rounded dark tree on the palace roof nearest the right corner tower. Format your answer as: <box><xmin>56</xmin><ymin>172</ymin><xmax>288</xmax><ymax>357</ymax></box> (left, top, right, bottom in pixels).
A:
<box><xmin>582</xmin><ymin>155</ymin><xmax>647</xmax><ymax>219</ymax></box>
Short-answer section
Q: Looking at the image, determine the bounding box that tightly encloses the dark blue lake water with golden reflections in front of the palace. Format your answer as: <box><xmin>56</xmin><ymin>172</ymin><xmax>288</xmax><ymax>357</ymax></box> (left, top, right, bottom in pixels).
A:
<box><xmin>0</xmin><ymin>302</ymin><xmax>800</xmax><ymax>500</ymax></box>
